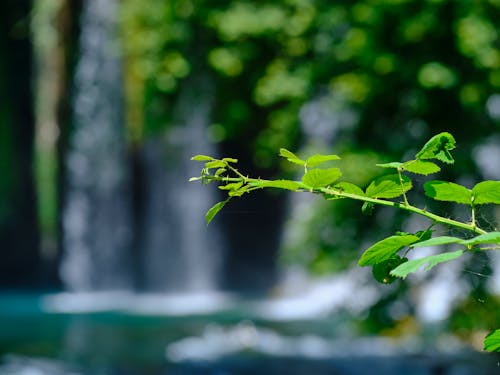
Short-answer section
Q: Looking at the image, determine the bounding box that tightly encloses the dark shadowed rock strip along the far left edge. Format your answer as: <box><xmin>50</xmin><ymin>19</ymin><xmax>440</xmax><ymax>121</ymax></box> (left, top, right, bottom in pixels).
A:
<box><xmin>0</xmin><ymin>0</ymin><xmax>40</xmax><ymax>287</ymax></box>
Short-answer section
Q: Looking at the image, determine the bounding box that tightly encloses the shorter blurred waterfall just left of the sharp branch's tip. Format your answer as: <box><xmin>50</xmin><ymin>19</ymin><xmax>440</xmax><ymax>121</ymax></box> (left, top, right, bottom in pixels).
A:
<box><xmin>139</xmin><ymin>78</ymin><xmax>222</xmax><ymax>292</ymax></box>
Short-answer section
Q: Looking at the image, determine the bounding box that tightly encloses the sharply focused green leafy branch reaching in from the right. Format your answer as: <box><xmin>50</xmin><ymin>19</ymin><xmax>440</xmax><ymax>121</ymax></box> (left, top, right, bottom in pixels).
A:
<box><xmin>190</xmin><ymin>132</ymin><xmax>500</xmax><ymax>351</ymax></box>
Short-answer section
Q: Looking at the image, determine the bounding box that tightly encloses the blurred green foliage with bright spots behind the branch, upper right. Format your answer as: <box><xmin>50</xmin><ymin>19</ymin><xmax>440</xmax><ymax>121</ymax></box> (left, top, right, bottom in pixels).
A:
<box><xmin>122</xmin><ymin>0</ymin><xmax>500</xmax><ymax>340</ymax></box>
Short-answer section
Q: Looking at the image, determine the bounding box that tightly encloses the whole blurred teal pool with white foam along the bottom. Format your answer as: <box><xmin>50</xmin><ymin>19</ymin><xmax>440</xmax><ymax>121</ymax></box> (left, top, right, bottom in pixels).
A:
<box><xmin>0</xmin><ymin>293</ymin><xmax>500</xmax><ymax>375</ymax></box>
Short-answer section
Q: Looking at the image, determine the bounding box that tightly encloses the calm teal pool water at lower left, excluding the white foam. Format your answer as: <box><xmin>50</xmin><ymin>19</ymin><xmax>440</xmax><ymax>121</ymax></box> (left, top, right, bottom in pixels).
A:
<box><xmin>0</xmin><ymin>294</ymin><xmax>239</xmax><ymax>374</ymax></box>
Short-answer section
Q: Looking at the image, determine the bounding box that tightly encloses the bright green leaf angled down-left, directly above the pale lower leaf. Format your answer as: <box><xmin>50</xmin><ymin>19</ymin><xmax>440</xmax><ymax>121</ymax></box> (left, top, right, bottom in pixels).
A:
<box><xmin>358</xmin><ymin>234</ymin><xmax>419</xmax><ymax>267</ymax></box>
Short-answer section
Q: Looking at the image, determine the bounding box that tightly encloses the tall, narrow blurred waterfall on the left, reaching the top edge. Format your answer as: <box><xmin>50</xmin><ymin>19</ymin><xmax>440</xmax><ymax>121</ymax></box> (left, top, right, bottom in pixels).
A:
<box><xmin>61</xmin><ymin>0</ymin><xmax>131</xmax><ymax>291</ymax></box>
